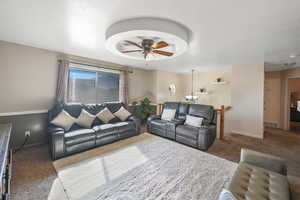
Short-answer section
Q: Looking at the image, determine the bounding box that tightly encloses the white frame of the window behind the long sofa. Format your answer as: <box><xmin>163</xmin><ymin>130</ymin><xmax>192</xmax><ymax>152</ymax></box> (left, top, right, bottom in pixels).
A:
<box><xmin>67</xmin><ymin>63</ymin><xmax>121</xmax><ymax>104</ymax></box>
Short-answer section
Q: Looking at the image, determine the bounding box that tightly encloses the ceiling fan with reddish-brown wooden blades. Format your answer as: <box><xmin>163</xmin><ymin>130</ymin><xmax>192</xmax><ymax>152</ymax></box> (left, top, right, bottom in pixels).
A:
<box><xmin>121</xmin><ymin>39</ymin><xmax>173</xmax><ymax>59</ymax></box>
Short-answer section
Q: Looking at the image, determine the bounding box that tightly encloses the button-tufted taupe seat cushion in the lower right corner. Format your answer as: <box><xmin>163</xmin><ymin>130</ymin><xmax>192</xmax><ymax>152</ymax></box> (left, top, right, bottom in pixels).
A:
<box><xmin>226</xmin><ymin>163</ymin><xmax>290</xmax><ymax>200</ymax></box>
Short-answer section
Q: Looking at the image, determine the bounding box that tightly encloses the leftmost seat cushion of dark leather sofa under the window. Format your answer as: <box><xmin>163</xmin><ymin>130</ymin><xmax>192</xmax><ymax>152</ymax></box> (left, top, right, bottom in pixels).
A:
<box><xmin>64</xmin><ymin>129</ymin><xmax>96</xmax><ymax>145</ymax></box>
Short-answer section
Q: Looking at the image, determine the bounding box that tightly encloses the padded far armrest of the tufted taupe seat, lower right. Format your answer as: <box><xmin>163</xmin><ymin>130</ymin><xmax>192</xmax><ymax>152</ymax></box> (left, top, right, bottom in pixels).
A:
<box><xmin>240</xmin><ymin>148</ymin><xmax>287</xmax><ymax>175</ymax></box>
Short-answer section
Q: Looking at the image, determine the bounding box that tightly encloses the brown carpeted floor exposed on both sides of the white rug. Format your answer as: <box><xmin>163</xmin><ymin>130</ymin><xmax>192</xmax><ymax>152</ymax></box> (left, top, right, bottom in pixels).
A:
<box><xmin>12</xmin><ymin>129</ymin><xmax>300</xmax><ymax>200</ymax></box>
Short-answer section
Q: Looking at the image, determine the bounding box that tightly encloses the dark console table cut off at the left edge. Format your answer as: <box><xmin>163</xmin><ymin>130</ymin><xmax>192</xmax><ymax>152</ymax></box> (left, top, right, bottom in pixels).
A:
<box><xmin>0</xmin><ymin>124</ymin><xmax>12</xmax><ymax>200</ymax></box>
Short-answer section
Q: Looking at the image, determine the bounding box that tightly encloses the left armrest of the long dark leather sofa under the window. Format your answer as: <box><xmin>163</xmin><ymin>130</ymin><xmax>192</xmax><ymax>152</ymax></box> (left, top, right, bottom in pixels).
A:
<box><xmin>48</xmin><ymin>125</ymin><xmax>65</xmax><ymax>160</ymax></box>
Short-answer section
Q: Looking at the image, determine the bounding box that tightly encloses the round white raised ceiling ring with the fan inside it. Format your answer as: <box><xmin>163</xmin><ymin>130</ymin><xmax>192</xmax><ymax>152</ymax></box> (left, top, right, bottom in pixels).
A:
<box><xmin>106</xmin><ymin>18</ymin><xmax>188</xmax><ymax>60</ymax></box>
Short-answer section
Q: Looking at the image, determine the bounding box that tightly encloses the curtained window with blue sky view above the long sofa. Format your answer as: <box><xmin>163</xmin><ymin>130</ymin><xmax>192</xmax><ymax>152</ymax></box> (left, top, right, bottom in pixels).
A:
<box><xmin>68</xmin><ymin>64</ymin><xmax>120</xmax><ymax>103</ymax></box>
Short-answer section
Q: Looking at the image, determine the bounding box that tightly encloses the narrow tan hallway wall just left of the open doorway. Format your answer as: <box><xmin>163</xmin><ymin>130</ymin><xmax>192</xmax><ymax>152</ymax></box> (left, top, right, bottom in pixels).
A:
<box><xmin>264</xmin><ymin>71</ymin><xmax>282</xmax><ymax>127</ymax></box>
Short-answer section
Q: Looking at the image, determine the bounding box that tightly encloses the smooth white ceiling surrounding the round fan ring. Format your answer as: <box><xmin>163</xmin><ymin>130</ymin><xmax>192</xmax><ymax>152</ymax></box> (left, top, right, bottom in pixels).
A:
<box><xmin>0</xmin><ymin>0</ymin><xmax>300</xmax><ymax>72</ymax></box>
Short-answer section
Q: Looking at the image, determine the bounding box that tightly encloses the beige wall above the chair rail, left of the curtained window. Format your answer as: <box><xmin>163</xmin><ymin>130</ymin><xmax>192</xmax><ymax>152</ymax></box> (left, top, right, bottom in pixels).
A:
<box><xmin>0</xmin><ymin>41</ymin><xmax>57</xmax><ymax>113</ymax></box>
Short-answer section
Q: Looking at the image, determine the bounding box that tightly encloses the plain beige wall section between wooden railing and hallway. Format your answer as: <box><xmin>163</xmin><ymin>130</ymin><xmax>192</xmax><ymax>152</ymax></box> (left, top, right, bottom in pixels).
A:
<box><xmin>227</xmin><ymin>63</ymin><xmax>264</xmax><ymax>138</ymax></box>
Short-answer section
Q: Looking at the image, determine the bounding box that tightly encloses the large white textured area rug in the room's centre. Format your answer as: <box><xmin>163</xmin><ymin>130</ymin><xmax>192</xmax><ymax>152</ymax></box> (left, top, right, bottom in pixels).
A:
<box><xmin>53</xmin><ymin>133</ymin><xmax>237</xmax><ymax>200</ymax></box>
